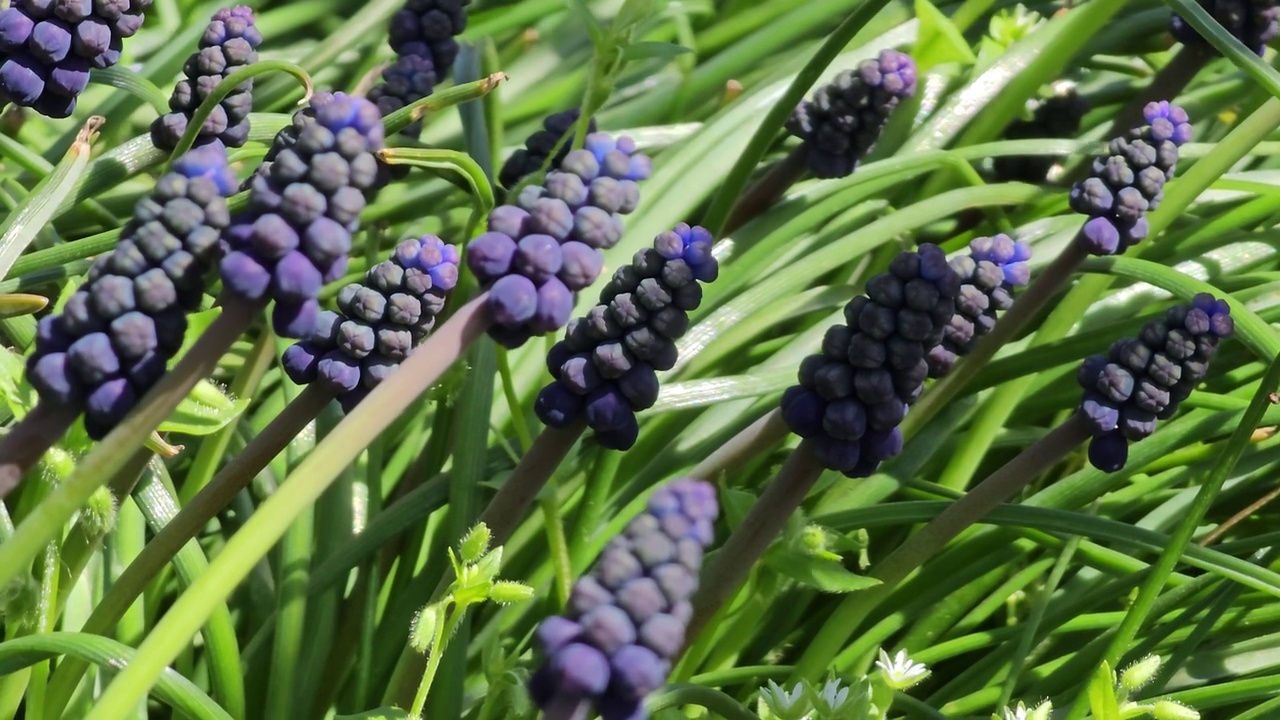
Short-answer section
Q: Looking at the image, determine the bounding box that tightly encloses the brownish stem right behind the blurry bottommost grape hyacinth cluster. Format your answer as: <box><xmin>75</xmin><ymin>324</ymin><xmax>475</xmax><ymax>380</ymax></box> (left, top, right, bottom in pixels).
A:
<box><xmin>685</xmin><ymin>441</ymin><xmax>822</xmax><ymax>643</ymax></box>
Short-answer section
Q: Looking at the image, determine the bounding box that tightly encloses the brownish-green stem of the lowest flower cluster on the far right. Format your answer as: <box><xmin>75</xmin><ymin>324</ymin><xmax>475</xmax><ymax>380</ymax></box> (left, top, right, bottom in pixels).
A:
<box><xmin>792</xmin><ymin>414</ymin><xmax>1089</xmax><ymax>676</ymax></box>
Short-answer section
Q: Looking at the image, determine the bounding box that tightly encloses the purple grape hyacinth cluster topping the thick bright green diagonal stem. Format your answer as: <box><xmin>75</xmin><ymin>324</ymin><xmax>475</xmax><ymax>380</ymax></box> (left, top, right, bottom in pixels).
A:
<box><xmin>466</xmin><ymin>132</ymin><xmax>652</xmax><ymax>347</ymax></box>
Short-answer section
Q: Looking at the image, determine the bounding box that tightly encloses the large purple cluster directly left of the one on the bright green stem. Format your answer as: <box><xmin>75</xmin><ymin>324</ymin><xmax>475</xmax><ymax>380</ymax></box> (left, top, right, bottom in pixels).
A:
<box><xmin>221</xmin><ymin>92</ymin><xmax>384</xmax><ymax>338</ymax></box>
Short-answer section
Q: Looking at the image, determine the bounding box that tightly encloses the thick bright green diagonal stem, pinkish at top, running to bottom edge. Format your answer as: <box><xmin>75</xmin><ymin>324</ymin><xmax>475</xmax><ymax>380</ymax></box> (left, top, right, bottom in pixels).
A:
<box><xmin>81</xmin><ymin>293</ymin><xmax>489</xmax><ymax>720</ymax></box>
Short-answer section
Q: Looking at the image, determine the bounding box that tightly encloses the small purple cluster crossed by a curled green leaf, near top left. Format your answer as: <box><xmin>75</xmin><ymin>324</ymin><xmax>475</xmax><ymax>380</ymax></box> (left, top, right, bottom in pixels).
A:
<box><xmin>151</xmin><ymin>5</ymin><xmax>262</xmax><ymax>150</ymax></box>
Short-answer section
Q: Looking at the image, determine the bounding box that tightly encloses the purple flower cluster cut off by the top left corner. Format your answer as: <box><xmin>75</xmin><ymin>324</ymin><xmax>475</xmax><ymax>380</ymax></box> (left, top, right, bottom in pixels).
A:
<box><xmin>0</xmin><ymin>0</ymin><xmax>151</xmax><ymax>118</ymax></box>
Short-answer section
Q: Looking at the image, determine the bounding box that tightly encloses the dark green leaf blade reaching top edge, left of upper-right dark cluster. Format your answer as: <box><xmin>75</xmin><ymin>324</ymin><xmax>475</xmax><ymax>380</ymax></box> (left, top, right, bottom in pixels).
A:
<box><xmin>703</xmin><ymin>0</ymin><xmax>888</xmax><ymax>237</ymax></box>
